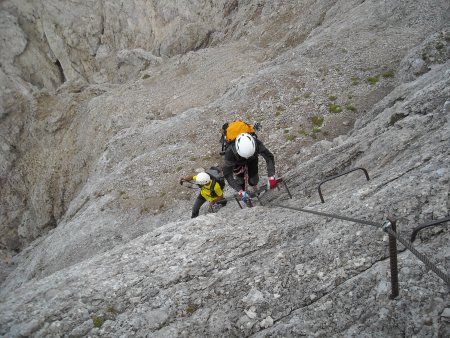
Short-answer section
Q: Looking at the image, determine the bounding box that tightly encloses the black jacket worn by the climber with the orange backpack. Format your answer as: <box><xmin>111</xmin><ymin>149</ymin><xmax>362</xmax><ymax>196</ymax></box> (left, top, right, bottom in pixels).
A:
<box><xmin>223</xmin><ymin>139</ymin><xmax>275</xmax><ymax>191</ymax></box>
